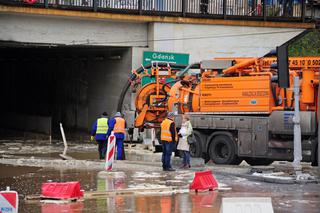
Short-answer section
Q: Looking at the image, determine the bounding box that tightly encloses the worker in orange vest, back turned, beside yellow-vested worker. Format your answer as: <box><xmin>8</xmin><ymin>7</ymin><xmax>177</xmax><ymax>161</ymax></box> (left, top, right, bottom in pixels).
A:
<box><xmin>113</xmin><ymin>112</ymin><xmax>127</xmax><ymax>160</ymax></box>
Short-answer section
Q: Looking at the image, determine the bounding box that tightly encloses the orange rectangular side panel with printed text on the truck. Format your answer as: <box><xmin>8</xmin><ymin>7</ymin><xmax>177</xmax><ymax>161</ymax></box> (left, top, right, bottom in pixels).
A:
<box><xmin>200</xmin><ymin>76</ymin><xmax>272</xmax><ymax>113</ymax></box>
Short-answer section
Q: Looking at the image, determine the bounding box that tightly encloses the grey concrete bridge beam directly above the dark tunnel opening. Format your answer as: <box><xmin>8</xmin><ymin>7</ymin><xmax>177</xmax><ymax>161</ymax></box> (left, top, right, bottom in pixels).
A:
<box><xmin>0</xmin><ymin>14</ymin><xmax>147</xmax><ymax>47</ymax></box>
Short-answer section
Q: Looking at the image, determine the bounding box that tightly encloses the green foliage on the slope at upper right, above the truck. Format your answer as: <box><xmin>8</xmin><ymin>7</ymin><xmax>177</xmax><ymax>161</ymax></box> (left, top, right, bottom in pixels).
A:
<box><xmin>289</xmin><ymin>30</ymin><xmax>320</xmax><ymax>56</ymax></box>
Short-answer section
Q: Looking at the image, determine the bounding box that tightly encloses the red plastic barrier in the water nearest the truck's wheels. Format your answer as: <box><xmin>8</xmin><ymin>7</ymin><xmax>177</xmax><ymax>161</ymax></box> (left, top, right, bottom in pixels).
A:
<box><xmin>190</xmin><ymin>170</ymin><xmax>218</xmax><ymax>191</ymax></box>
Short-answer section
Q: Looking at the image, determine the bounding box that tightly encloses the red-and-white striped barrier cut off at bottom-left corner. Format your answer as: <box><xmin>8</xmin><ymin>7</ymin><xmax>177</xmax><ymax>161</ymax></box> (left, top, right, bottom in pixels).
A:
<box><xmin>0</xmin><ymin>187</ymin><xmax>19</xmax><ymax>213</ymax></box>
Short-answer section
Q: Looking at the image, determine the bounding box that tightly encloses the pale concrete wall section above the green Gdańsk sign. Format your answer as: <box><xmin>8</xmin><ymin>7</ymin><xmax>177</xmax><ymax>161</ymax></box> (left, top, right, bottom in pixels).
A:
<box><xmin>148</xmin><ymin>23</ymin><xmax>303</xmax><ymax>62</ymax></box>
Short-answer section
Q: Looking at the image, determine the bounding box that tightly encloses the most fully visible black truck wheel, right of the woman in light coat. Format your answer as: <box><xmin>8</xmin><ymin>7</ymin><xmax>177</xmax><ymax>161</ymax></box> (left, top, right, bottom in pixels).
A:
<box><xmin>209</xmin><ymin>135</ymin><xmax>241</xmax><ymax>164</ymax></box>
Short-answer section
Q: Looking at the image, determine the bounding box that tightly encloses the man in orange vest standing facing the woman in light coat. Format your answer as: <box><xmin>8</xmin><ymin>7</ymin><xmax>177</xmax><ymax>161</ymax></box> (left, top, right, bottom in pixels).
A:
<box><xmin>161</xmin><ymin>112</ymin><xmax>178</xmax><ymax>171</ymax></box>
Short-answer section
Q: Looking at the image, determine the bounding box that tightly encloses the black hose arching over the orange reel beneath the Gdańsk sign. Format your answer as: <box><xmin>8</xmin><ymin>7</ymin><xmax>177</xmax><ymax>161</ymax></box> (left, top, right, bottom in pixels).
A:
<box><xmin>117</xmin><ymin>62</ymin><xmax>199</xmax><ymax>112</ymax></box>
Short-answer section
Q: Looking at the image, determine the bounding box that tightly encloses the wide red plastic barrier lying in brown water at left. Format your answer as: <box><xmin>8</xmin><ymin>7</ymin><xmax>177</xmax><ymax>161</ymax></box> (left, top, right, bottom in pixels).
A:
<box><xmin>41</xmin><ymin>181</ymin><xmax>83</xmax><ymax>199</ymax></box>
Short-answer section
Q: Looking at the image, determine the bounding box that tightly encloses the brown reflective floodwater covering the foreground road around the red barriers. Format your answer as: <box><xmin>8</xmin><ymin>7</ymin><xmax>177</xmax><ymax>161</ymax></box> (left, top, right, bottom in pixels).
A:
<box><xmin>0</xmin><ymin>162</ymin><xmax>320</xmax><ymax>213</ymax></box>
